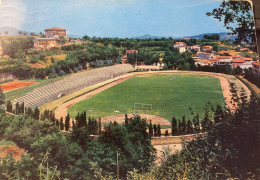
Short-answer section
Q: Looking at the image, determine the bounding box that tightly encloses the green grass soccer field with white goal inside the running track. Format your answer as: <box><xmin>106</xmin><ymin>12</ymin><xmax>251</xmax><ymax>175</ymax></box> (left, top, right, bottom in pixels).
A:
<box><xmin>68</xmin><ymin>74</ymin><xmax>224</xmax><ymax>120</ymax></box>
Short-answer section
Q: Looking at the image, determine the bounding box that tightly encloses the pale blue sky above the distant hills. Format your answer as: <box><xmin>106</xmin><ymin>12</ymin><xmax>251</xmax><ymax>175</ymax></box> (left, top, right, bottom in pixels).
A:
<box><xmin>0</xmin><ymin>0</ymin><xmax>235</xmax><ymax>38</ymax></box>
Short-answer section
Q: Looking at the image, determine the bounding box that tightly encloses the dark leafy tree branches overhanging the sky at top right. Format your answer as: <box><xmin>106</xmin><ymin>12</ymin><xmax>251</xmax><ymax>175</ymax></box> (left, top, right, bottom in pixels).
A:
<box><xmin>206</xmin><ymin>1</ymin><xmax>256</xmax><ymax>46</ymax></box>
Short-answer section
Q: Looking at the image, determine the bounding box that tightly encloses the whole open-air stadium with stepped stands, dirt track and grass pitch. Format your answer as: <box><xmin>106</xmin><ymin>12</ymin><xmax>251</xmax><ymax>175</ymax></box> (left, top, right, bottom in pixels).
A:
<box><xmin>9</xmin><ymin>64</ymin><xmax>250</xmax><ymax>129</ymax></box>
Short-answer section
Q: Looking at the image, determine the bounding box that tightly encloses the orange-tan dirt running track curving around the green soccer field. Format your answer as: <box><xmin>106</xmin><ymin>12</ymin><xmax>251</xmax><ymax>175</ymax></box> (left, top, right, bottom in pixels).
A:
<box><xmin>55</xmin><ymin>71</ymin><xmax>249</xmax><ymax>125</ymax></box>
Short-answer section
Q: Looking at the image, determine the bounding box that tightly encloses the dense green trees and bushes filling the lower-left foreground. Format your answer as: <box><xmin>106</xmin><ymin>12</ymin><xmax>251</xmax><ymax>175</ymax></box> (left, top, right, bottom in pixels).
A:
<box><xmin>0</xmin><ymin>110</ymin><xmax>155</xmax><ymax>180</ymax></box>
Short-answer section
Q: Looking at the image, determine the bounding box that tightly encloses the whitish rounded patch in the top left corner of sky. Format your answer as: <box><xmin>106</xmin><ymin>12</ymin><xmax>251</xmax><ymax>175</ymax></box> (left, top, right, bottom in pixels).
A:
<box><xmin>0</xmin><ymin>0</ymin><xmax>26</xmax><ymax>29</ymax></box>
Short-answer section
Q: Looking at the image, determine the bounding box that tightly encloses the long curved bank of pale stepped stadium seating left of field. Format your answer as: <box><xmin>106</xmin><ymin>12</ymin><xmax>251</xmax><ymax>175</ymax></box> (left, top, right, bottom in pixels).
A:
<box><xmin>12</xmin><ymin>64</ymin><xmax>134</xmax><ymax>108</ymax></box>
